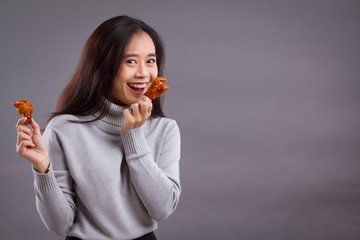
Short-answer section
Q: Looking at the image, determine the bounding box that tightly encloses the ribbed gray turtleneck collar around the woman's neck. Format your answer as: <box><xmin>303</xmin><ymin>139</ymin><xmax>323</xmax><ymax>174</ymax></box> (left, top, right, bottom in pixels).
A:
<box><xmin>94</xmin><ymin>99</ymin><xmax>128</xmax><ymax>134</ymax></box>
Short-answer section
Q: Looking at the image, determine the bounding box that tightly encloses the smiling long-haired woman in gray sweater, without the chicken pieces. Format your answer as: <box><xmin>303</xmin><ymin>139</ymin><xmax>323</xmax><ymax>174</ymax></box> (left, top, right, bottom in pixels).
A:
<box><xmin>17</xmin><ymin>16</ymin><xmax>181</xmax><ymax>239</ymax></box>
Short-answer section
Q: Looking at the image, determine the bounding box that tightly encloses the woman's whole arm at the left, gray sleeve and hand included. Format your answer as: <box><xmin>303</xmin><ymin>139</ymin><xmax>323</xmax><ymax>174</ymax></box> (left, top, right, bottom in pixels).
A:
<box><xmin>16</xmin><ymin>118</ymin><xmax>76</xmax><ymax>234</ymax></box>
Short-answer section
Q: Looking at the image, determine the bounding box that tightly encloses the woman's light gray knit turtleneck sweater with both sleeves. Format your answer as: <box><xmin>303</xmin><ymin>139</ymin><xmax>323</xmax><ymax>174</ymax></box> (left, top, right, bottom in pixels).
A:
<box><xmin>33</xmin><ymin>102</ymin><xmax>181</xmax><ymax>240</ymax></box>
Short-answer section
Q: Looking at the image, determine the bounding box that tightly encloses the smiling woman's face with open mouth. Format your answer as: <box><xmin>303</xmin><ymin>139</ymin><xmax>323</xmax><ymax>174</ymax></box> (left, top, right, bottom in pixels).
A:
<box><xmin>111</xmin><ymin>32</ymin><xmax>158</xmax><ymax>105</ymax></box>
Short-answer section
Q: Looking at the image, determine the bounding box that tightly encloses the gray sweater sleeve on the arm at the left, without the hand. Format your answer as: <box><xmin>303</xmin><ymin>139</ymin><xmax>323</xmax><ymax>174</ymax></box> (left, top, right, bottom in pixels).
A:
<box><xmin>33</xmin><ymin>129</ymin><xmax>76</xmax><ymax>235</ymax></box>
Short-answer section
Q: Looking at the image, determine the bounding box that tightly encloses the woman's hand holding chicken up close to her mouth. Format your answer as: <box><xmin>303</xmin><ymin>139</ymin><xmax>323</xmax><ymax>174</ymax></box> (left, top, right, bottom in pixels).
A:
<box><xmin>121</xmin><ymin>96</ymin><xmax>152</xmax><ymax>130</ymax></box>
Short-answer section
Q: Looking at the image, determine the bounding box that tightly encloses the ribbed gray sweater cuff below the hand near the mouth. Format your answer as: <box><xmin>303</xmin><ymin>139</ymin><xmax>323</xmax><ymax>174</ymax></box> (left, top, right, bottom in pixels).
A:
<box><xmin>121</xmin><ymin>127</ymin><xmax>151</xmax><ymax>158</ymax></box>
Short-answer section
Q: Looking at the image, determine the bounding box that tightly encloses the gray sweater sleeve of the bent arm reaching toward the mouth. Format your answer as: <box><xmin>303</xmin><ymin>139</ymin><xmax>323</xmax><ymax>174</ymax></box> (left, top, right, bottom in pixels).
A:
<box><xmin>121</xmin><ymin>121</ymin><xmax>181</xmax><ymax>221</ymax></box>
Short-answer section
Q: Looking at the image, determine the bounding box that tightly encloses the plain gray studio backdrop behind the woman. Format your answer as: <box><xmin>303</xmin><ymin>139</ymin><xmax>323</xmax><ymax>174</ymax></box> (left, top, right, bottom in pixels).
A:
<box><xmin>0</xmin><ymin>0</ymin><xmax>360</xmax><ymax>240</ymax></box>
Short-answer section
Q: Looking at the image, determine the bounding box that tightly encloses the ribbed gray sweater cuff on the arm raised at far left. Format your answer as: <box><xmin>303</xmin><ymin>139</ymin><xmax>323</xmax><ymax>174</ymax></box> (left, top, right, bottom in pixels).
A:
<box><xmin>32</xmin><ymin>167</ymin><xmax>57</xmax><ymax>192</ymax></box>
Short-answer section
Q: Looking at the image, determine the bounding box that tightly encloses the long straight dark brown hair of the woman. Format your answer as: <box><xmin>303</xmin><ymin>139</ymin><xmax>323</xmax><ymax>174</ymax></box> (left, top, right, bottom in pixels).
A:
<box><xmin>48</xmin><ymin>16</ymin><xmax>165</xmax><ymax>122</ymax></box>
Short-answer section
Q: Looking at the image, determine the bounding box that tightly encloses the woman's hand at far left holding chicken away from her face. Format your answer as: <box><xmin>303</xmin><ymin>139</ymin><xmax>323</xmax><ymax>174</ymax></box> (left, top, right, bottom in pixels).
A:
<box><xmin>16</xmin><ymin>118</ymin><xmax>50</xmax><ymax>173</ymax></box>
